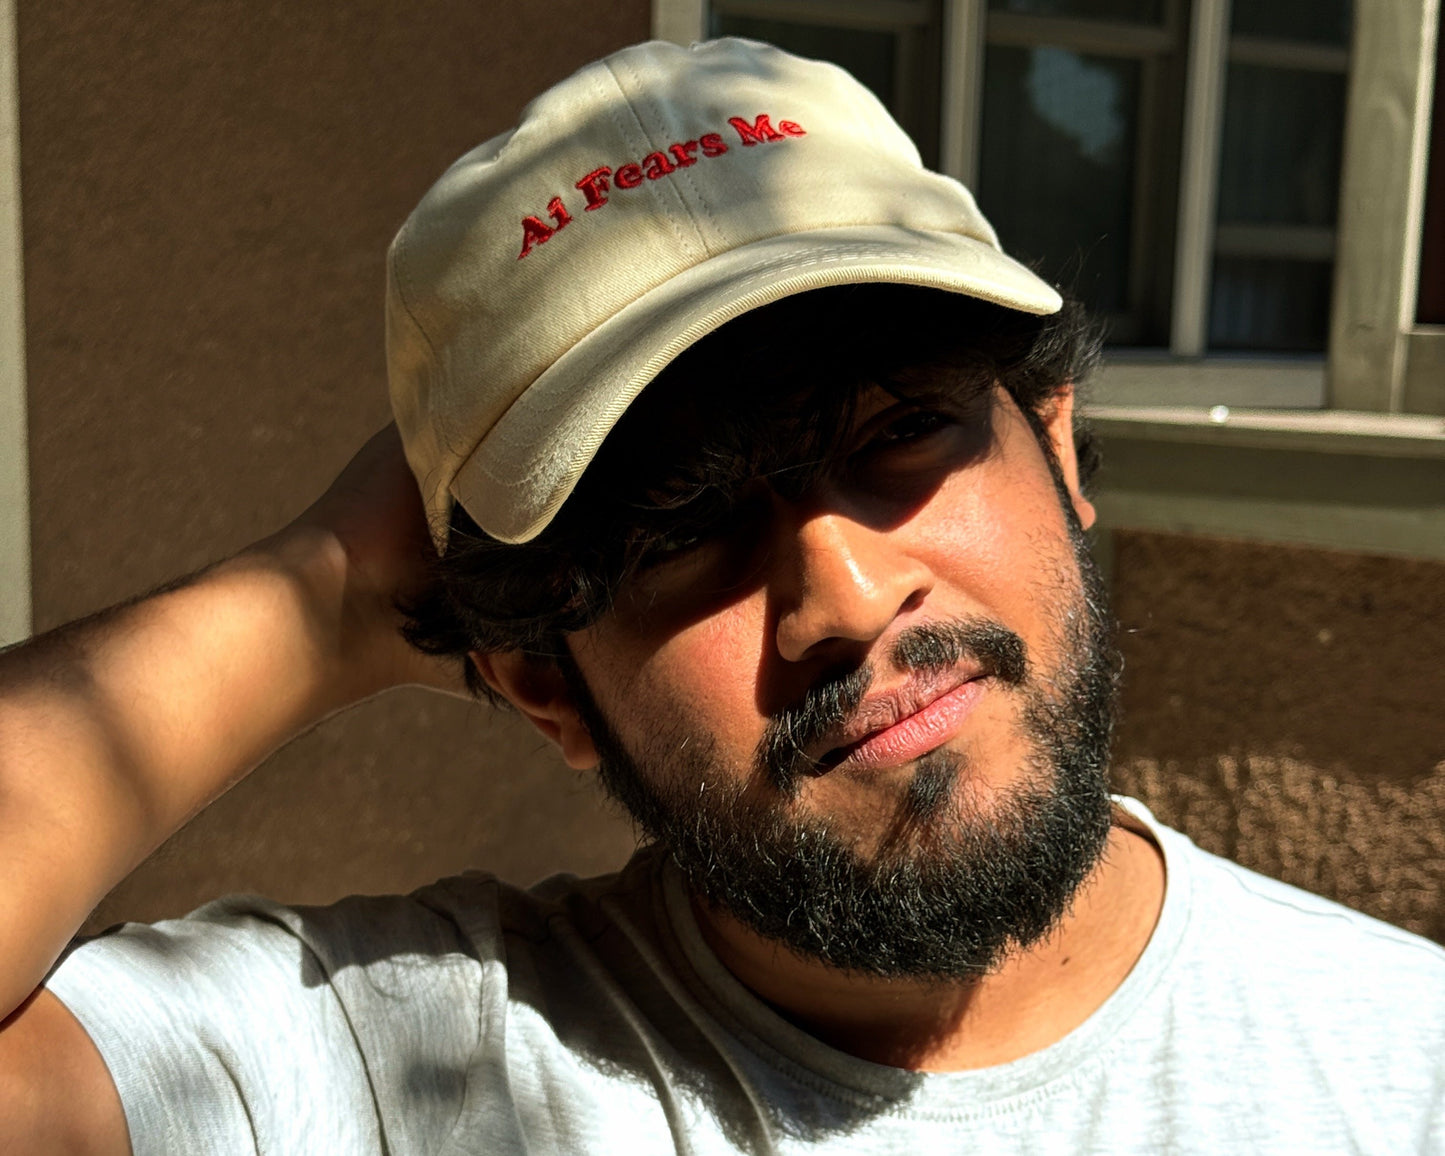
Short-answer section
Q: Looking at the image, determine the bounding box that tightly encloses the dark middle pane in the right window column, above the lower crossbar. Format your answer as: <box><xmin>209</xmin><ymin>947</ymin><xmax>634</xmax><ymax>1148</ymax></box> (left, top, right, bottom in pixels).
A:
<box><xmin>1220</xmin><ymin>64</ymin><xmax>1345</xmax><ymax>227</ymax></box>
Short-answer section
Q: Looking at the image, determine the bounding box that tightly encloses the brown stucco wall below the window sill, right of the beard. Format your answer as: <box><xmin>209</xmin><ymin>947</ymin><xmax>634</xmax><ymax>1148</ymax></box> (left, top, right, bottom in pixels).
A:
<box><xmin>1114</xmin><ymin>533</ymin><xmax>1445</xmax><ymax>942</ymax></box>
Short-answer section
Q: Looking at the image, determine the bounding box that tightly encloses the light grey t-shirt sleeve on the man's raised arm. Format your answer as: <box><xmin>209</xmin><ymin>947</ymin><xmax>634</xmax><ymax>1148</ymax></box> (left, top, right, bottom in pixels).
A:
<box><xmin>46</xmin><ymin>896</ymin><xmax>497</xmax><ymax>1156</ymax></box>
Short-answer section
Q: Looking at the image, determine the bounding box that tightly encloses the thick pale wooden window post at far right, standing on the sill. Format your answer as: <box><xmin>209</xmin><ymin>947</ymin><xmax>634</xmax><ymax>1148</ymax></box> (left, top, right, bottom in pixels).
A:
<box><xmin>1328</xmin><ymin>0</ymin><xmax>1439</xmax><ymax>412</ymax></box>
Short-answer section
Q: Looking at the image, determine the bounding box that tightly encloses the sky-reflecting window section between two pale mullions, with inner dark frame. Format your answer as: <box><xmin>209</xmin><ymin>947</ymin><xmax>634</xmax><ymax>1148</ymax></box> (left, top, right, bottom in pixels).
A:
<box><xmin>974</xmin><ymin>0</ymin><xmax>1183</xmax><ymax>345</ymax></box>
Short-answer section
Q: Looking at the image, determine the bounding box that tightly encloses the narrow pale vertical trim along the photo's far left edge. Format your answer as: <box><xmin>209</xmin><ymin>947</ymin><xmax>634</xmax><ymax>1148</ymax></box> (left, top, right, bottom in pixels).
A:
<box><xmin>0</xmin><ymin>0</ymin><xmax>32</xmax><ymax>646</ymax></box>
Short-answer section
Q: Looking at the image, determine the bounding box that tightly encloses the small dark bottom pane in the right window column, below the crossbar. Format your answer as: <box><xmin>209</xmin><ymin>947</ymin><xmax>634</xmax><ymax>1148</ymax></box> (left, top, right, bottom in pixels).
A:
<box><xmin>1209</xmin><ymin>257</ymin><xmax>1332</xmax><ymax>353</ymax></box>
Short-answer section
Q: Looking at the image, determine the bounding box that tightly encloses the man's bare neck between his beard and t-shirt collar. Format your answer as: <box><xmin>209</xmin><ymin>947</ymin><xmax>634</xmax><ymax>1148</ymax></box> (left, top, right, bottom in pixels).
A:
<box><xmin>692</xmin><ymin>815</ymin><xmax>1165</xmax><ymax>1071</ymax></box>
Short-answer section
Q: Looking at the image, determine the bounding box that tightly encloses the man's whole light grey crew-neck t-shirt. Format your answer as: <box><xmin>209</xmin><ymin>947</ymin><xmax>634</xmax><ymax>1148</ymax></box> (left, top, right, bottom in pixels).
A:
<box><xmin>49</xmin><ymin>801</ymin><xmax>1445</xmax><ymax>1156</ymax></box>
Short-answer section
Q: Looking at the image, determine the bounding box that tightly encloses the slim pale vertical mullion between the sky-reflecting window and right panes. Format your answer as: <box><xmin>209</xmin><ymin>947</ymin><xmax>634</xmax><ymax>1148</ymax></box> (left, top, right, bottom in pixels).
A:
<box><xmin>1169</xmin><ymin>0</ymin><xmax>1230</xmax><ymax>357</ymax></box>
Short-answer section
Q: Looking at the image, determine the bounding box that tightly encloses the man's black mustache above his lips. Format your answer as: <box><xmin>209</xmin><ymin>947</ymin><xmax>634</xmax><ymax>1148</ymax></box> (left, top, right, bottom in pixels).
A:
<box><xmin>754</xmin><ymin>618</ymin><xmax>1029</xmax><ymax>798</ymax></box>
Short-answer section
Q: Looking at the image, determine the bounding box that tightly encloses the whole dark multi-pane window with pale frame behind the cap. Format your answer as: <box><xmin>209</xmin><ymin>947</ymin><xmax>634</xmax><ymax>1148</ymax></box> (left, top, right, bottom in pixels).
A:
<box><xmin>679</xmin><ymin>0</ymin><xmax>1433</xmax><ymax>409</ymax></box>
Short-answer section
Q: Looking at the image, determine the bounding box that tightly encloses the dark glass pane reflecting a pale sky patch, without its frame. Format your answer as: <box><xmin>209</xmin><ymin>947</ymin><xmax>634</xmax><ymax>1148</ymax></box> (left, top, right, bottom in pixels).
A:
<box><xmin>978</xmin><ymin>46</ymin><xmax>1140</xmax><ymax>312</ymax></box>
